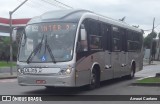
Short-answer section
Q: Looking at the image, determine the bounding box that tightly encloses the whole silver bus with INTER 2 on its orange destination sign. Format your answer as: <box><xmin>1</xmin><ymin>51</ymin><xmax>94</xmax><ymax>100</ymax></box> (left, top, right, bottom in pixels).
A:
<box><xmin>17</xmin><ymin>10</ymin><xmax>143</xmax><ymax>89</ymax></box>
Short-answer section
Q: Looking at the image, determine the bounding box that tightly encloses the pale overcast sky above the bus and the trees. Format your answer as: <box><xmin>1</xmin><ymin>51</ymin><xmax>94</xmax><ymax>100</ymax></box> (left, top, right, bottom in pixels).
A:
<box><xmin>0</xmin><ymin>0</ymin><xmax>160</xmax><ymax>36</ymax></box>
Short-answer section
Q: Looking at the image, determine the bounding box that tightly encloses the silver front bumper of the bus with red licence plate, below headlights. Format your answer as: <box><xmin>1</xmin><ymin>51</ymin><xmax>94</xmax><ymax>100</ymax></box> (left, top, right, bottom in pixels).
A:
<box><xmin>17</xmin><ymin>75</ymin><xmax>75</xmax><ymax>87</ymax></box>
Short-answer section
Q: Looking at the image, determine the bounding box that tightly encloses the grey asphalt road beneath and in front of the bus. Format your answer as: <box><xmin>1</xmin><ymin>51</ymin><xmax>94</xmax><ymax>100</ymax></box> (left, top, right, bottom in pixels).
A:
<box><xmin>0</xmin><ymin>78</ymin><xmax>138</xmax><ymax>95</ymax></box>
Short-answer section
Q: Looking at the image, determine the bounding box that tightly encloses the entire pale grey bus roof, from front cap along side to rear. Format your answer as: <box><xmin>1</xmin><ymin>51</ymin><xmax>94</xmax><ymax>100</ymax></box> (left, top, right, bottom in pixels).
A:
<box><xmin>28</xmin><ymin>9</ymin><xmax>143</xmax><ymax>32</ymax></box>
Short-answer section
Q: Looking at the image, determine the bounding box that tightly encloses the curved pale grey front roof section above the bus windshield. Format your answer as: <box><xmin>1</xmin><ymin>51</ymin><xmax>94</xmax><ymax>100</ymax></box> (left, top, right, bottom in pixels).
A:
<box><xmin>28</xmin><ymin>9</ymin><xmax>91</xmax><ymax>24</ymax></box>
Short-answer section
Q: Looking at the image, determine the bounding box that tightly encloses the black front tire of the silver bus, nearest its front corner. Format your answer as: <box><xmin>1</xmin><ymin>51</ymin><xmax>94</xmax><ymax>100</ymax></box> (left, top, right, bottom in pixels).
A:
<box><xmin>88</xmin><ymin>68</ymin><xmax>100</xmax><ymax>90</ymax></box>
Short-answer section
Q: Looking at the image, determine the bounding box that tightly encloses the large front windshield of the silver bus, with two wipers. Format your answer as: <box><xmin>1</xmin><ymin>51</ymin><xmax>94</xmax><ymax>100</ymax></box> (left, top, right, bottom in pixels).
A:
<box><xmin>19</xmin><ymin>23</ymin><xmax>77</xmax><ymax>62</ymax></box>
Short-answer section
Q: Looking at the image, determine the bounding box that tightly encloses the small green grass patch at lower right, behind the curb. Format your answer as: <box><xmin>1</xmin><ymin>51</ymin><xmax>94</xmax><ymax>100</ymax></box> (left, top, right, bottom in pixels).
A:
<box><xmin>137</xmin><ymin>77</ymin><xmax>160</xmax><ymax>83</ymax></box>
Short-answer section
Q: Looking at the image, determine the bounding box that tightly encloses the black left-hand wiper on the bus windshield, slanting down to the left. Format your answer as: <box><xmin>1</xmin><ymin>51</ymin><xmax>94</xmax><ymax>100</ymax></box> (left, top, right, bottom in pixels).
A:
<box><xmin>27</xmin><ymin>34</ymin><xmax>44</xmax><ymax>63</ymax></box>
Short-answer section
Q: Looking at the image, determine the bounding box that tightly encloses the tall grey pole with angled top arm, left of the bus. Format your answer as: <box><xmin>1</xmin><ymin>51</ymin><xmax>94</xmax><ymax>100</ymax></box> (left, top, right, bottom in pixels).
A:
<box><xmin>9</xmin><ymin>0</ymin><xmax>28</xmax><ymax>75</ymax></box>
